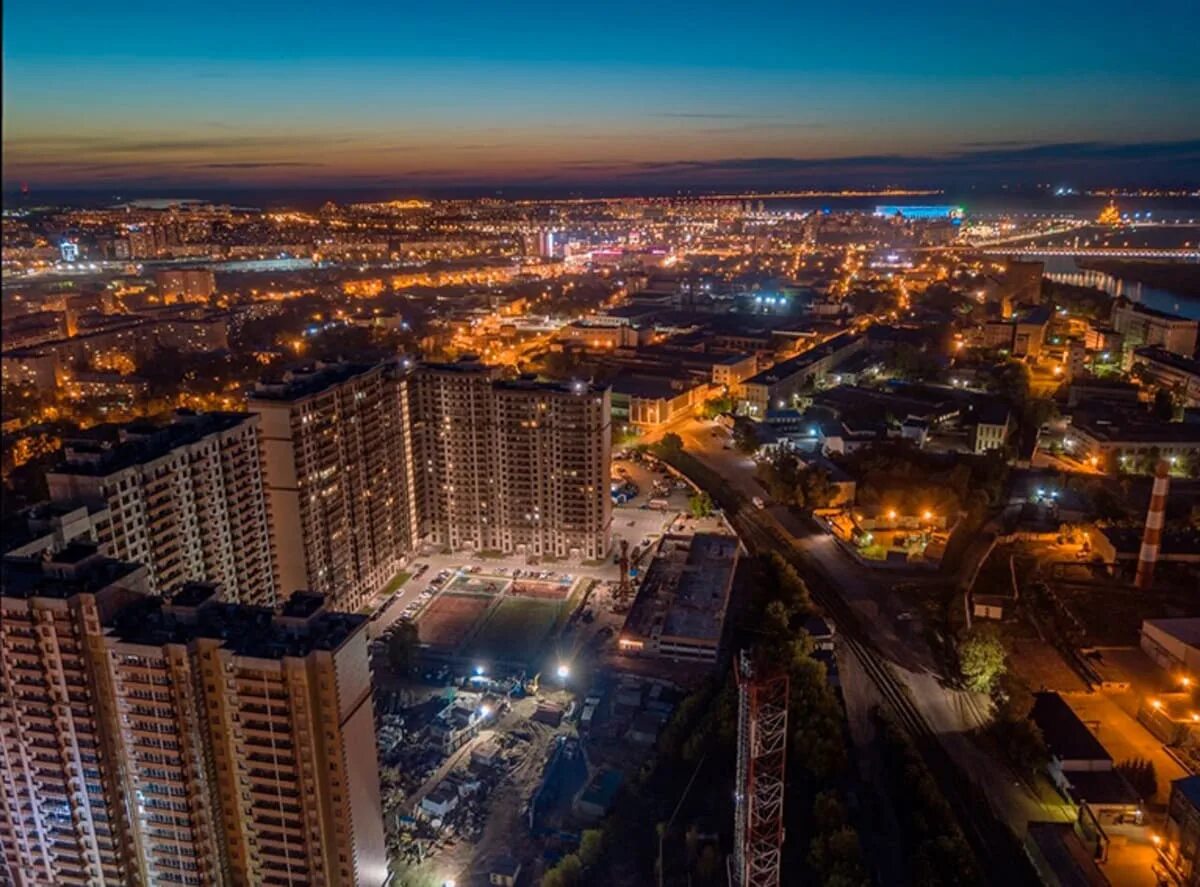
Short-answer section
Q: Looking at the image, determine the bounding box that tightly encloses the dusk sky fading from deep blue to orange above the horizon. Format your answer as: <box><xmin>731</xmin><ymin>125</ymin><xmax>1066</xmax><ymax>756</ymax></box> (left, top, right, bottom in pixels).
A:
<box><xmin>4</xmin><ymin>0</ymin><xmax>1200</xmax><ymax>191</ymax></box>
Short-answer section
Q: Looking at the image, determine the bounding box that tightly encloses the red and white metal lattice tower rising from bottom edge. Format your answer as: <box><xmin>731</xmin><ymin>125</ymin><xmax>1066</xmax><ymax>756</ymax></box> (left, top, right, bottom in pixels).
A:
<box><xmin>733</xmin><ymin>651</ymin><xmax>788</xmax><ymax>887</ymax></box>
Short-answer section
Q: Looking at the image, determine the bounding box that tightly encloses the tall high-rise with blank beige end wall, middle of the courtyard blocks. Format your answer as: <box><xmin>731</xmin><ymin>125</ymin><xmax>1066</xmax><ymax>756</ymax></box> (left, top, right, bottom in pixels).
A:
<box><xmin>250</xmin><ymin>364</ymin><xmax>416</xmax><ymax>611</ymax></box>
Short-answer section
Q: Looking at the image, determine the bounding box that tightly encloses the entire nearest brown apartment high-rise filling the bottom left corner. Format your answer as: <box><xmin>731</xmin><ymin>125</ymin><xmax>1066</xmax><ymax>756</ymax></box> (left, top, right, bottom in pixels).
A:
<box><xmin>0</xmin><ymin>545</ymin><xmax>388</xmax><ymax>887</ymax></box>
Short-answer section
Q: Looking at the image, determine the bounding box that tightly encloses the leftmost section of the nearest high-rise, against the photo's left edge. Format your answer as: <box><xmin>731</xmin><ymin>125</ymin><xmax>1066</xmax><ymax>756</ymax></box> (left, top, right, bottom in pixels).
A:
<box><xmin>0</xmin><ymin>544</ymin><xmax>145</xmax><ymax>887</ymax></box>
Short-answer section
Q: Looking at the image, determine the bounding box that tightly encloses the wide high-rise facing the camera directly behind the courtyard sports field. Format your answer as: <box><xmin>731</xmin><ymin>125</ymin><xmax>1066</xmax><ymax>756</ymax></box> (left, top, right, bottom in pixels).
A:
<box><xmin>404</xmin><ymin>360</ymin><xmax>612</xmax><ymax>558</ymax></box>
